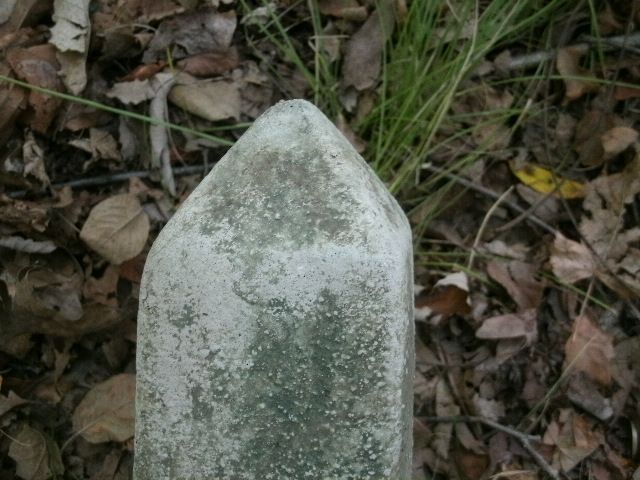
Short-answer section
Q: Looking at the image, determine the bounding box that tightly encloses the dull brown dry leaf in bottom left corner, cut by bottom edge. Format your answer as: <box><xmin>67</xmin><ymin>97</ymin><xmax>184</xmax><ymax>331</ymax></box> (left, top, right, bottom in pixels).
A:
<box><xmin>9</xmin><ymin>423</ymin><xmax>53</xmax><ymax>480</ymax></box>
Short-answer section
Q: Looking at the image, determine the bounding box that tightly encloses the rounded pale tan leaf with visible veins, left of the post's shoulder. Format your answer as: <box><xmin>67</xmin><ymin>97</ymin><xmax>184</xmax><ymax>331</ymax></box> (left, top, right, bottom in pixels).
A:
<box><xmin>80</xmin><ymin>193</ymin><xmax>149</xmax><ymax>264</ymax></box>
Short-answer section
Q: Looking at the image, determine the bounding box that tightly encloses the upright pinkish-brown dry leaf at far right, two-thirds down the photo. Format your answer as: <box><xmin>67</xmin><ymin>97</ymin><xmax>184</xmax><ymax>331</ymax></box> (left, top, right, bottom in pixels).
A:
<box><xmin>565</xmin><ymin>315</ymin><xmax>614</xmax><ymax>386</ymax></box>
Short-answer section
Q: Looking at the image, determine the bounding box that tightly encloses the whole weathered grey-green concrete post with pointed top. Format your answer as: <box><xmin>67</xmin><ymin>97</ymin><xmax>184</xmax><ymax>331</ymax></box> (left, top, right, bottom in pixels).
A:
<box><xmin>135</xmin><ymin>100</ymin><xmax>413</xmax><ymax>480</ymax></box>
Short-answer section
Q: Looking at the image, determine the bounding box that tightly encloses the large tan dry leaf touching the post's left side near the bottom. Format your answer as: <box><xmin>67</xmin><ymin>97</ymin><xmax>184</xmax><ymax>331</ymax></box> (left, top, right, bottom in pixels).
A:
<box><xmin>72</xmin><ymin>373</ymin><xmax>136</xmax><ymax>443</ymax></box>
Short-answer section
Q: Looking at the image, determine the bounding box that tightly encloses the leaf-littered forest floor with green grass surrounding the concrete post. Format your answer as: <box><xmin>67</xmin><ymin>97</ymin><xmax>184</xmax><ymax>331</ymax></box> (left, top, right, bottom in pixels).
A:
<box><xmin>0</xmin><ymin>0</ymin><xmax>640</xmax><ymax>480</ymax></box>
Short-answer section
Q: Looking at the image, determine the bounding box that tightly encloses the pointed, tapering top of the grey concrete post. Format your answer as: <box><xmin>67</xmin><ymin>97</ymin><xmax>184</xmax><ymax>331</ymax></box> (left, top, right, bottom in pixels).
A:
<box><xmin>179</xmin><ymin>99</ymin><xmax>411</xmax><ymax>251</ymax></box>
